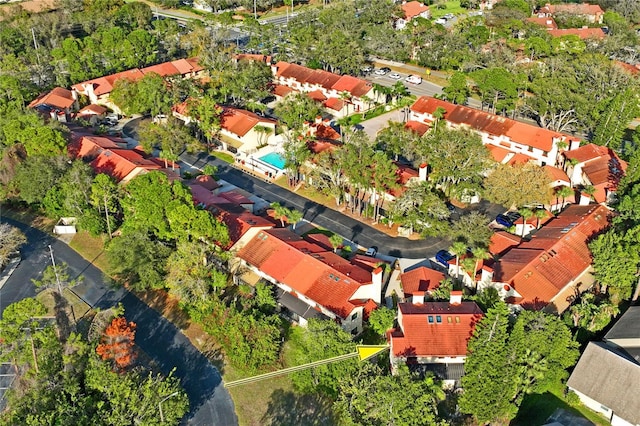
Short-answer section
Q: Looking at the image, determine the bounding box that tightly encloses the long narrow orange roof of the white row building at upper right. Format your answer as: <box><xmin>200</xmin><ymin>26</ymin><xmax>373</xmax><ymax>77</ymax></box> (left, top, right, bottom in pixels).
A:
<box><xmin>411</xmin><ymin>96</ymin><xmax>573</xmax><ymax>152</ymax></box>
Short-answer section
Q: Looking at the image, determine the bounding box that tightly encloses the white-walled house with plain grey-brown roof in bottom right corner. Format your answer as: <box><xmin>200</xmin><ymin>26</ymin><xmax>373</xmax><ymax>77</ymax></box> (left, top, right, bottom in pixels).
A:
<box><xmin>567</xmin><ymin>342</ymin><xmax>640</xmax><ymax>426</ymax></box>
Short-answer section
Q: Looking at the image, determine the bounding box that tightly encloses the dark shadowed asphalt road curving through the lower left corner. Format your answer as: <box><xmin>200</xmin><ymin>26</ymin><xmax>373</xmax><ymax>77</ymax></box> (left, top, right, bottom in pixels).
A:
<box><xmin>0</xmin><ymin>218</ymin><xmax>238</xmax><ymax>426</ymax></box>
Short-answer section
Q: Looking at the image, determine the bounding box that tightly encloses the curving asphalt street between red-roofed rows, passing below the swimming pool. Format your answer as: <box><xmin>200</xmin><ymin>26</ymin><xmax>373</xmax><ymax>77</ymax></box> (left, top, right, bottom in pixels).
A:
<box><xmin>180</xmin><ymin>152</ymin><xmax>504</xmax><ymax>259</ymax></box>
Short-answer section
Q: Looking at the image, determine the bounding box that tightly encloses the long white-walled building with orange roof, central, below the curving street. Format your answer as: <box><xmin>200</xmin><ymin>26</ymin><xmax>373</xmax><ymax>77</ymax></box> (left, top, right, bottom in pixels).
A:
<box><xmin>237</xmin><ymin>228</ymin><xmax>383</xmax><ymax>334</ymax></box>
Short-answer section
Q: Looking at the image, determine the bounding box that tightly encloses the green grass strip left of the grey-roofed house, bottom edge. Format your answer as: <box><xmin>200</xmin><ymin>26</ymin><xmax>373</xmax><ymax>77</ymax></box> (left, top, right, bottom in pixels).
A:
<box><xmin>511</xmin><ymin>385</ymin><xmax>609</xmax><ymax>426</ymax></box>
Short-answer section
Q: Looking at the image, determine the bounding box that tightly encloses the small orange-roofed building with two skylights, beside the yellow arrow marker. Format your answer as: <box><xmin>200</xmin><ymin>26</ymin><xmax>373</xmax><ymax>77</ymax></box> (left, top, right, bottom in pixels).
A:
<box><xmin>387</xmin><ymin>291</ymin><xmax>483</xmax><ymax>386</ymax></box>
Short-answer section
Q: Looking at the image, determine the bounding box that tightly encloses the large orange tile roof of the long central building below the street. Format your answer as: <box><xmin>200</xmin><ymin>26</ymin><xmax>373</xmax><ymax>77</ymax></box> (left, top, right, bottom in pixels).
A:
<box><xmin>237</xmin><ymin>228</ymin><xmax>372</xmax><ymax>318</ymax></box>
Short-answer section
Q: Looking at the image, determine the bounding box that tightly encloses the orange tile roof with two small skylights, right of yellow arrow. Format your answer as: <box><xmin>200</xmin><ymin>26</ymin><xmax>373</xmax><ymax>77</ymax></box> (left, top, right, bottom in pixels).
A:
<box><xmin>390</xmin><ymin>302</ymin><xmax>483</xmax><ymax>357</ymax></box>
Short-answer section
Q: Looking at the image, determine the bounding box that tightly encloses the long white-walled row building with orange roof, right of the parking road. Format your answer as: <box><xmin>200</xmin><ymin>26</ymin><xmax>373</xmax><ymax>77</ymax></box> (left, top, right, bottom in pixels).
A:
<box><xmin>409</xmin><ymin>96</ymin><xmax>580</xmax><ymax>166</ymax></box>
